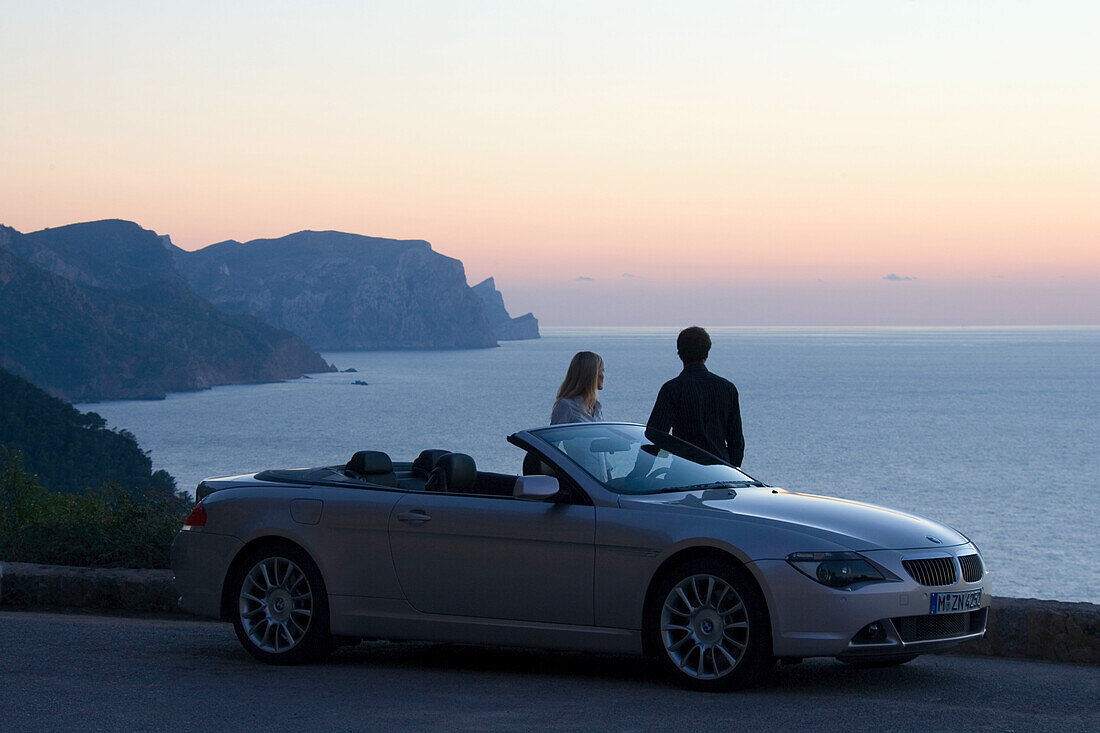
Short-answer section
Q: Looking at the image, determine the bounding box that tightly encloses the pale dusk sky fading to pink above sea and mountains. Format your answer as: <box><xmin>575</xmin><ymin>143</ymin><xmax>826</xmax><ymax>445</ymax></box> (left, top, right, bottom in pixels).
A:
<box><xmin>0</xmin><ymin>0</ymin><xmax>1100</xmax><ymax>326</ymax></box>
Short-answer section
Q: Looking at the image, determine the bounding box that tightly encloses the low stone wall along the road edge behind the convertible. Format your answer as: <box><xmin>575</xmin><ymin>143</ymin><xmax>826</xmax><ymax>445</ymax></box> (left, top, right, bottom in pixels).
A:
<box><xmin>0</xmin><ymin>562</ymin><xmax>1100</xmax><ymax>665</ymax></box>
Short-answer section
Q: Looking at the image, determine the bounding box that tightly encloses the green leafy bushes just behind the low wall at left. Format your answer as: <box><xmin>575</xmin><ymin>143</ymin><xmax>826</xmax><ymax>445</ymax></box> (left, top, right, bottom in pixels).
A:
<box><xmin>0</xmin><ymin>450</ymin><xmax>190</xmax><ymax>568</ymax></box>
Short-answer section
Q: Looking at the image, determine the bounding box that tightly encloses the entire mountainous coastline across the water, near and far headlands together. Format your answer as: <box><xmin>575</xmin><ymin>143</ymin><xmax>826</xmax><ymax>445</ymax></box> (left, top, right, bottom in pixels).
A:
<box><xmin>0</xmin><ymin>219</ymin><xmax>539</xmax><ymax>400</ymax></box>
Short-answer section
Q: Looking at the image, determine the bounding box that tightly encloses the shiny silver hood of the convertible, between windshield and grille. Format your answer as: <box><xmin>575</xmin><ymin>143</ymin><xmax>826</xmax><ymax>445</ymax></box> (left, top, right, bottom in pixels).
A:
<box><xmin>620</xmin><ymin>486</ymin><xmax>969</xmax><ymax>550</ymax></box>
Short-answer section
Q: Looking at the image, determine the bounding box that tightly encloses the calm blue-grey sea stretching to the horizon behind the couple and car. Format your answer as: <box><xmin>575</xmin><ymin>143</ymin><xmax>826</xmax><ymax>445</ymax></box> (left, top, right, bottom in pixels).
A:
<box><xmin>77</xmin><ymin>328</ymin><xmax>1100</xmax><ymax>603</ymax></box>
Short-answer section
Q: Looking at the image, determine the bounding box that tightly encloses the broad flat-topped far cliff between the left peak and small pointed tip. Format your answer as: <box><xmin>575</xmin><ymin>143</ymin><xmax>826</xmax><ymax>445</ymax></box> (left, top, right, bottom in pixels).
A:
<box><xmin>176</xmin><ymin>231</ymin><xmax>496</xmax><ymax>350</ymax></box>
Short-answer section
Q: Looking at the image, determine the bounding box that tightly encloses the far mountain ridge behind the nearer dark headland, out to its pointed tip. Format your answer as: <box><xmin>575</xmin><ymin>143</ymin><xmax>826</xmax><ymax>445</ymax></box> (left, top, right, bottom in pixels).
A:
<box><xmin>9</xmin><ymin>219</ymin><xmax>539</xmax><ymax>350</ymax></box>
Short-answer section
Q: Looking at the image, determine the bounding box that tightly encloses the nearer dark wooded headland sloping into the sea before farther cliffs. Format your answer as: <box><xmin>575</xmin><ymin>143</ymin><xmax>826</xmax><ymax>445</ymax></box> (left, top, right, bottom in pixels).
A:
<box><xmin>0</xmin><ymin>227</ymin><xmax>333</xmax><ymax>402</ymax></box>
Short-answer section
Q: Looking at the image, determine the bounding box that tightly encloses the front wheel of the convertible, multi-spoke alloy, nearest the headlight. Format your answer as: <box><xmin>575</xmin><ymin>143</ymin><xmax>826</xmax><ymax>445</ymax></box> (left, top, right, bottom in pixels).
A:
<box><xmin>647</xmin><ymin>559</ymin><xmax>774</xmax><ymax>691</ymax></box>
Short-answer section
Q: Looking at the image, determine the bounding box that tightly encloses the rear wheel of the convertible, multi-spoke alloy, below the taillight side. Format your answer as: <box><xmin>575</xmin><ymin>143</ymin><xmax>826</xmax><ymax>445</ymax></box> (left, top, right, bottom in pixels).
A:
<box><xmin>233</xmin><ymin>545</ymin><xmax>332</xmax><ymax>665</ymax></box>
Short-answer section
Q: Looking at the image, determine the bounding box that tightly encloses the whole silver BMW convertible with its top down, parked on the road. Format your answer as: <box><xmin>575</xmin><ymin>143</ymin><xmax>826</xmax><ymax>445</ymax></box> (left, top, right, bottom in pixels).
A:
<box><xmin>172</xmin><ymin>423</ymin><xmax>990</xmax><ymax>690</ymax></box>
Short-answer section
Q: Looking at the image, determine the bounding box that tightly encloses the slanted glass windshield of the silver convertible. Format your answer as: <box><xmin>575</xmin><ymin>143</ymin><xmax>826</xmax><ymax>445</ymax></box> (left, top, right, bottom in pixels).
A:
<box><xmin>531</xmin><ymin>423</ymin><xmax>763</xmax><ymax>494</ymax></box>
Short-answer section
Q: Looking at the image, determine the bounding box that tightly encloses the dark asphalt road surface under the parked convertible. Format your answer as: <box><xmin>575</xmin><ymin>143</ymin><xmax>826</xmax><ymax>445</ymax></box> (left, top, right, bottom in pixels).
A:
<box><xmin>0</xmin><ymin>612</ymin><xmax>1100</xmax><ymax>733</ymax></box>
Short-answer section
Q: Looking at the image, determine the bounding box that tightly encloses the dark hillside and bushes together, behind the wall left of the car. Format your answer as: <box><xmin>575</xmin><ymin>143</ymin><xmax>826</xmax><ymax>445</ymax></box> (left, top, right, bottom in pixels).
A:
<box><xmin>0</xmin><ymin>370</ymin><xmax>191</xmax><ymax>568</ymax></box>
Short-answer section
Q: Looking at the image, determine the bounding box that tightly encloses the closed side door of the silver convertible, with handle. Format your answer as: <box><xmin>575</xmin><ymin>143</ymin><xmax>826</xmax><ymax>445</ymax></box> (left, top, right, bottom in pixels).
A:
<box><xmin>389</xmin><ymin>493</ymin><xmax>595</xmax><ymax>625</ymax></box>
